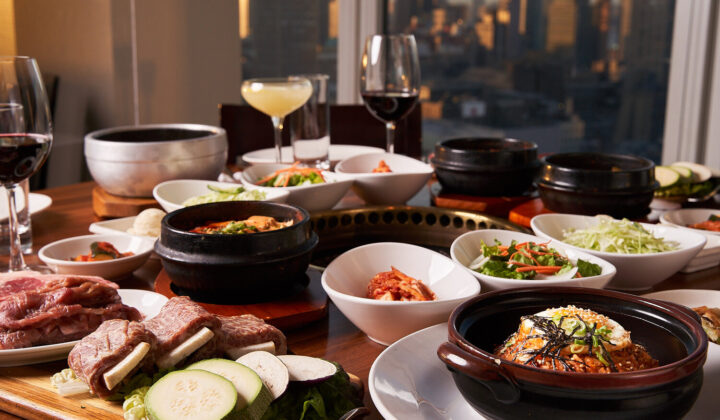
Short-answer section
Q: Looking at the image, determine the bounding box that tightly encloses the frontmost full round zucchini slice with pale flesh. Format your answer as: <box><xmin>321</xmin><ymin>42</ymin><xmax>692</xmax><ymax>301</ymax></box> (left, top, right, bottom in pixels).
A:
<box><xmin>145</xmin><ymin>370</ymin><xmax>238</xmax><ymax>420</ymax></box>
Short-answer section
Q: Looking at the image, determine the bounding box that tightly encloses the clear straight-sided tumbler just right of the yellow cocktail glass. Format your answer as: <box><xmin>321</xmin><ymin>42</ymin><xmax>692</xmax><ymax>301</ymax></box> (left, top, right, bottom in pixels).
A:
<box><xmin>290</xmin><ymin>74</ymin><xmax>330</xmax><ymax>169</ymax></box>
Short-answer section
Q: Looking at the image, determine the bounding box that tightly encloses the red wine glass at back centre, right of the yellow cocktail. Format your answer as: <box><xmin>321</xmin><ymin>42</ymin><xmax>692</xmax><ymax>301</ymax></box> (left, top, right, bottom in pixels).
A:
<box><xmin>360</xmin><ymin>35</ymin><xmax>420</xmax><ymax>153</ymax></box>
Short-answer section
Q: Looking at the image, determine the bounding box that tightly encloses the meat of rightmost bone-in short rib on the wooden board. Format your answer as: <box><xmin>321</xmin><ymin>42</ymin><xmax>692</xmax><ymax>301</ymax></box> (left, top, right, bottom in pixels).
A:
<box><xmin>218</xmin><ymin>314</ymin><xmax>287</xmax><ymax>359</ymax></box>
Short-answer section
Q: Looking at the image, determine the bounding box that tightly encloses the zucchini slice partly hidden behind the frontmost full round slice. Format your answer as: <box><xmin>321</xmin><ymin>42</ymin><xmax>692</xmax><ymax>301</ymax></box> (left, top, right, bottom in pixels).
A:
<box><xmin>187</xmin><ymin>359</ymin><xmax>273</xmax><ymax>420</ymax></box>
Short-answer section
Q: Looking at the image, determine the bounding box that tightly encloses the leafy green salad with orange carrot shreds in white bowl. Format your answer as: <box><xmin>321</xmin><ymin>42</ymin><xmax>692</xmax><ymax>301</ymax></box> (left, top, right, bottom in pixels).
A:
<box><xmin>469</xmin><ymin>239</ymin><xmax>602</xmax><ymax>280</ymax></box>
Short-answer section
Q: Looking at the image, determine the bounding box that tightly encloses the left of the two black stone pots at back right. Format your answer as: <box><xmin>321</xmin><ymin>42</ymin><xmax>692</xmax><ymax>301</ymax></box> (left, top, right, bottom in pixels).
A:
<box><xmin>431</xmin><ymin>138</ymin><xmax>540</xmax><ymax>196</ymax></box>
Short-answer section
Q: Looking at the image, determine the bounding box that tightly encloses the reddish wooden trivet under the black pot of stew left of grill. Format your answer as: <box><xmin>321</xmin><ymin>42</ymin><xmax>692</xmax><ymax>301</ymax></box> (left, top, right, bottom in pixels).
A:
<box><xmin>155</xmin><ymin>269</ymin><xmax>328</xmax><ymax>329</ymax></box>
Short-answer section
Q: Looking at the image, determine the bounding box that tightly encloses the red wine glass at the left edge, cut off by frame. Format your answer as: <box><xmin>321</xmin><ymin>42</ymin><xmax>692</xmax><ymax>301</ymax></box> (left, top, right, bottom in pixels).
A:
<box><xmin>0</xmin><ymin>57</ymin><xmax>52</xmax><ymax>271</ymax></box>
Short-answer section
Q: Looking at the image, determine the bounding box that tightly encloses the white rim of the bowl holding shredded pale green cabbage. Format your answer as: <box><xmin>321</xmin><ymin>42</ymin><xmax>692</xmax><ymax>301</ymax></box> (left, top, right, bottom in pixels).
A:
<box><xmin>530</xmin><ymin>213</ymin><xmax>707</xmax><ymax>259</ymax></box>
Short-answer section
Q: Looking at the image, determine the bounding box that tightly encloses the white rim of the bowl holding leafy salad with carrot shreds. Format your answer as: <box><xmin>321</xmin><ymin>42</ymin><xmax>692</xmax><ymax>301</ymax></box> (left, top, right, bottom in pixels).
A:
<box><xmin>450</xmin><ymin>229</ymin><xmax>617</xmax><ymax>287</ymax></box>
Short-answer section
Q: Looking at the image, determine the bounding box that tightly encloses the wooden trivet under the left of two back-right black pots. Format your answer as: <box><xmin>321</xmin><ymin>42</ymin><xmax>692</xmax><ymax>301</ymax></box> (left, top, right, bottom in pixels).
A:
<box><xmin>430</xmin><ymin>183</ymin><xmax>536</xmax><ymax>218</ymax></box>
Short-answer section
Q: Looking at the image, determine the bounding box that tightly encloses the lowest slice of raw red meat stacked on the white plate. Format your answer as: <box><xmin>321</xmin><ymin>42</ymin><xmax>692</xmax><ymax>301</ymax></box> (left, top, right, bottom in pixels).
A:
<box><xmin>0</xmin><ymin>303</ymin><xmax>142</xmax><ymax>350</ymax></box>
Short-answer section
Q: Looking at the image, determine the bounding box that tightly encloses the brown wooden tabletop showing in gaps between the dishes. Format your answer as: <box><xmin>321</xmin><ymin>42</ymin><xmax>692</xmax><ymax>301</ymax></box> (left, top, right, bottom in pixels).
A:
<box><xmin>0</xmin><ymin>182</ymin><xmax>720</xmax><ymax>419</ymax></box>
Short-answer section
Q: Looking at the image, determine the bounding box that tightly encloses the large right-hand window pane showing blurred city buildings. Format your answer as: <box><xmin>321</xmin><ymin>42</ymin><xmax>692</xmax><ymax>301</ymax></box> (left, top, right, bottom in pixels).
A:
<box><xmin>385</xmin><ymin>0</ymin><xmax>675</xmax><ymax>162</ymax></box>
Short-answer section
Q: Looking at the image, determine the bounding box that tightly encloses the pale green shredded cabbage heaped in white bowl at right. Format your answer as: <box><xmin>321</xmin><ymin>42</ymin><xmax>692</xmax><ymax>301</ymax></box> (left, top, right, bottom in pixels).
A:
<box><xmin>563</xmin><ymin>216</ymin><xmax>679</xmax><ymax>254</ymax></box>
